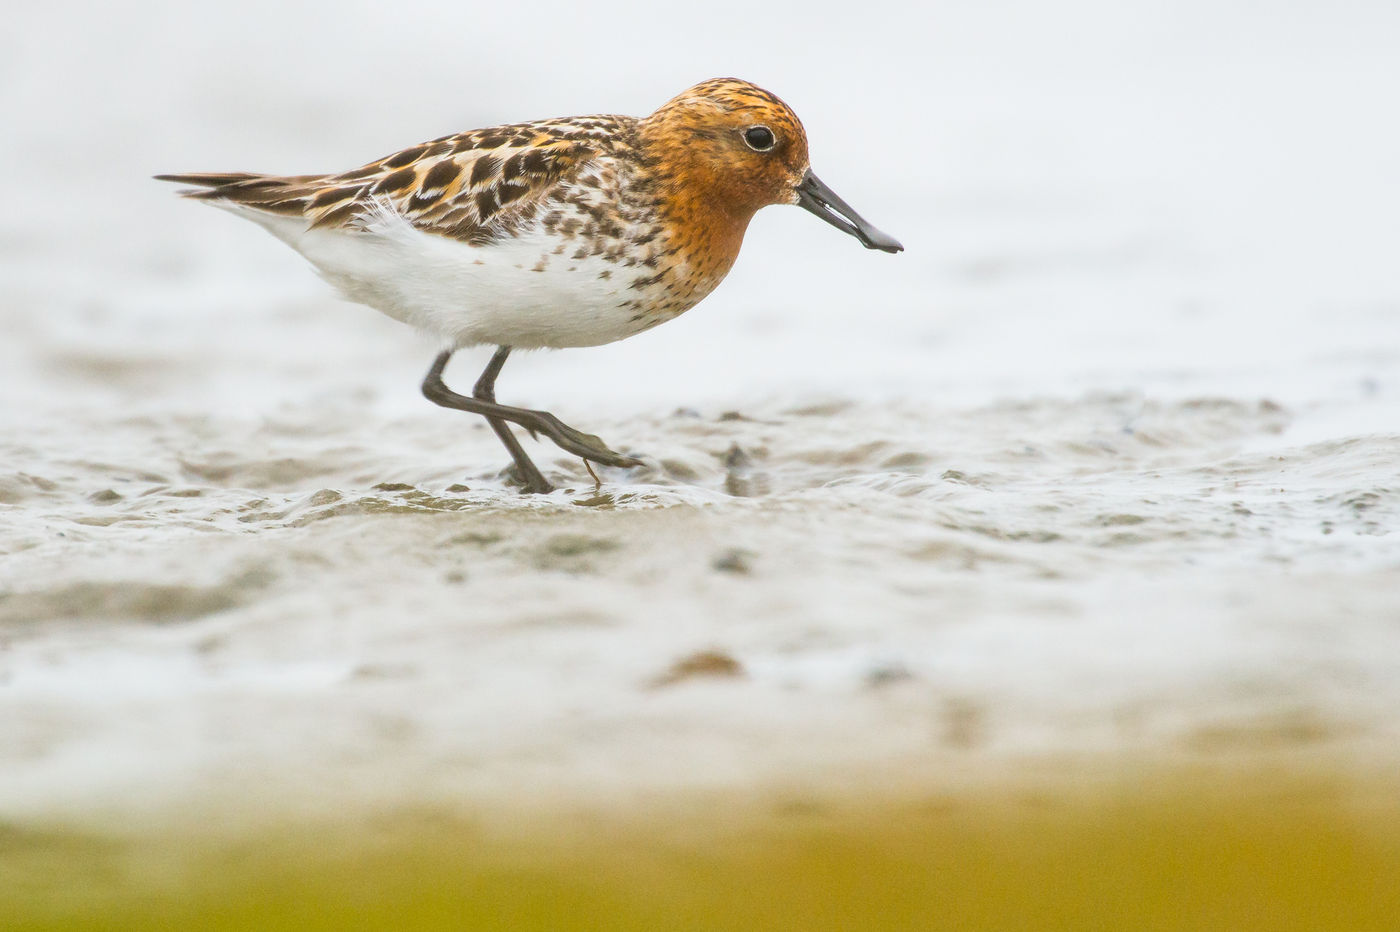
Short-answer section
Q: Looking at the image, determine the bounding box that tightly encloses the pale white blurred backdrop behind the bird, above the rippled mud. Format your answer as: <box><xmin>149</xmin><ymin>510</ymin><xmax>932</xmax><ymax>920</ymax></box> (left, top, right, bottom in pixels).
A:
<box><xmin>3</xmin><ymin>1</ymin><xmax>1400</xmax><ymax>410</ymax></box>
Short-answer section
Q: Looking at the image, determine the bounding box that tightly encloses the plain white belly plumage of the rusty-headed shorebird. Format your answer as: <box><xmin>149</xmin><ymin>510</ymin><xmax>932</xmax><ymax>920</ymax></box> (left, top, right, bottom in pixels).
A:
<box><xmin>232</xmin><ymin>207</ymin><xmax>671</xmax><ymax>348</ymax></box>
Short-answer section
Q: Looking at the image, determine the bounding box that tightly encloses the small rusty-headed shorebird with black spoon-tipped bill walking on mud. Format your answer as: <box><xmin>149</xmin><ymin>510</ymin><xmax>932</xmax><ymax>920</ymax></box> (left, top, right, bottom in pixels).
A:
<box><xmin>157</xmin><ymin>78</ymin><xmax>903</xmax><ymax>493</ymax></box>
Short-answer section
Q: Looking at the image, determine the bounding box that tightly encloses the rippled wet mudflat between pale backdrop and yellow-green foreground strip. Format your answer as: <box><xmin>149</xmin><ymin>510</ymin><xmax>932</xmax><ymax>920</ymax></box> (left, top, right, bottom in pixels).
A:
<box><xmin>8</xmin><ymin>363</ymin><xmax>1400</xmax><ymax>828</ymax></box>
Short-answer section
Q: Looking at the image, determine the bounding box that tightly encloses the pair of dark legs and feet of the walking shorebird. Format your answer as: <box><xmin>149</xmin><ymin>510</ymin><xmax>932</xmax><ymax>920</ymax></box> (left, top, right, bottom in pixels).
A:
<box><xmin>423</xmin><ymin>346</ymin><xmax>641</xmax><ymax>493</ymax></box>
